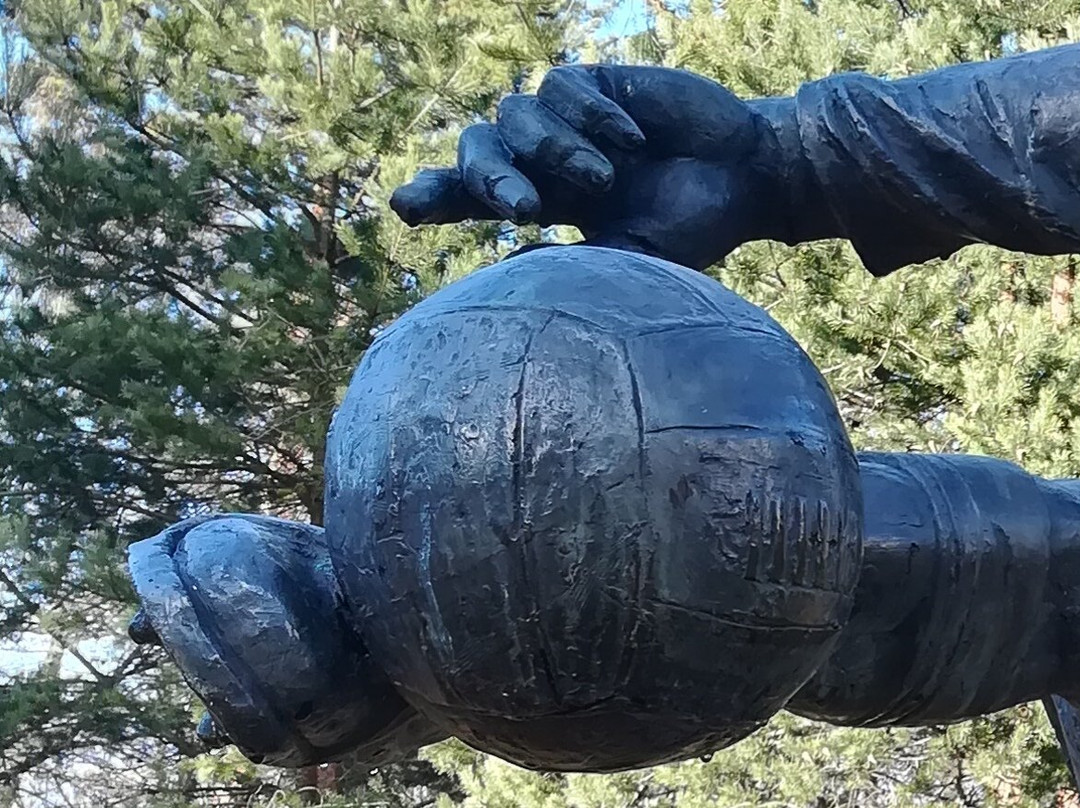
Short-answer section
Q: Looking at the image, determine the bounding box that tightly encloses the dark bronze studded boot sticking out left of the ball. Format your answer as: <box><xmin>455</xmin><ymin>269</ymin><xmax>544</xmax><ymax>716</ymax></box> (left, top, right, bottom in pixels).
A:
<box><xmin>129</xmin><ymin>514</ymin><xmax>444</xmax><ymax>766</ymax></box>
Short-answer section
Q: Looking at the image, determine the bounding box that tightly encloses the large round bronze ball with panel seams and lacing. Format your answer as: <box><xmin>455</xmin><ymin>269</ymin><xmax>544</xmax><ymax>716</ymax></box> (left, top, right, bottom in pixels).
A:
<box><xmin>326</xmin><ymin>246</ymin><xmax>862</xmax><ymax>771</ymax></box>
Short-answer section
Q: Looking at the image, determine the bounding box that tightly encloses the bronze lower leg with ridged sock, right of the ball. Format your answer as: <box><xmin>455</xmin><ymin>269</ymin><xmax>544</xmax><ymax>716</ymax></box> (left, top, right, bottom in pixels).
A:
<box><xmin>791</xmin><ymin>454</ymin><xmax>1067</xmax><ymax>725</ymax></box>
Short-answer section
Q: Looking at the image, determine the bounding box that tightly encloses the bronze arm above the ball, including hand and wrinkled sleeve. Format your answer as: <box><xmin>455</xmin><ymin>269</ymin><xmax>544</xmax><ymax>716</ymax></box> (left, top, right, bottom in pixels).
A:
<box><xmin>391</xmin><ymin>45</ymin><xmax>1080</xmax><ymax>275</ymax></box>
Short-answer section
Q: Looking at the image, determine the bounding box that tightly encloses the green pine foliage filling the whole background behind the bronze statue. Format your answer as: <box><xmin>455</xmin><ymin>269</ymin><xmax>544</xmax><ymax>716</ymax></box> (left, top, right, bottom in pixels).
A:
<box><xmin>0</xmin><ymin>0</ymin><xmax>1080</xmax><ymax>808</ymax></box>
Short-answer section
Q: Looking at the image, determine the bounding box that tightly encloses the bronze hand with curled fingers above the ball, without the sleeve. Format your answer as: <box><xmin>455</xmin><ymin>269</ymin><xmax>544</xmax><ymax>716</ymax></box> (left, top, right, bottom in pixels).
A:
<box><xmin>391</xmin><ymin>65</ymin><xmax>786</xmax><ymax>268</ymax></box>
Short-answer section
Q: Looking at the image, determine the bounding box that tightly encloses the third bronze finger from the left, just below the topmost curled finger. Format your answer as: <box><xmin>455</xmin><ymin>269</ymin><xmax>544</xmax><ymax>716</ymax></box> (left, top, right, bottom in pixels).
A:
<box><xmin>498</xmin><ymin>95</ymin><xmax>615</xmax><ymax>193</ymax></box>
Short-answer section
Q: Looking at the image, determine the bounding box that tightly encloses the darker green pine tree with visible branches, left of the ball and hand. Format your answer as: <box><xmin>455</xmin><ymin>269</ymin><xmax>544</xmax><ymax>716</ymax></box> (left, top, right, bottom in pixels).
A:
<box><xmin>0</xmin><ymin>0</ymin><xmax>583</xmax><ymax>805</ymax></box>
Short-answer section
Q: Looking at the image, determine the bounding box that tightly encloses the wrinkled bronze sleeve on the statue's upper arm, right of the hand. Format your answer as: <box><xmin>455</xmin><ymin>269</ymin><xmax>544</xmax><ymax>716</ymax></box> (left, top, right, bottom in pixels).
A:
<box><xmin>795</xmin><ymin>45</ymin><xmax>1080</xmax><ymax>275</ymax></box>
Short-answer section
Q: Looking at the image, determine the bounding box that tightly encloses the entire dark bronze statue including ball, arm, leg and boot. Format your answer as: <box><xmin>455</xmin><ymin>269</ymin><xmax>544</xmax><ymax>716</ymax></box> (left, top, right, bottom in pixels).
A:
<box><xmin>131</xmin><ymin>46</ymin><xmax>1080</xmax><ymax>771</ymax></box>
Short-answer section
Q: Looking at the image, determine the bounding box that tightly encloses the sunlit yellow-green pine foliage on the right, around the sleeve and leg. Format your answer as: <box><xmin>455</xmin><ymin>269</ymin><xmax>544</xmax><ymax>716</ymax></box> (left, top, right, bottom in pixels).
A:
<box><xmin>419</xmin><ymin>0</ymin><xmax>1080</xmax><ymax>808</ymax></box>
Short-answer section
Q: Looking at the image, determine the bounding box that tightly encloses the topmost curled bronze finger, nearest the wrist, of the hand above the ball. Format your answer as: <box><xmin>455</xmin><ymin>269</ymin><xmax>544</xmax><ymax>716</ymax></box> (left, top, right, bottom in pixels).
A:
<box><xmin>537</xmin><ymin>67</ymin><xmax>645</xmax><ymax>149</ymax></box>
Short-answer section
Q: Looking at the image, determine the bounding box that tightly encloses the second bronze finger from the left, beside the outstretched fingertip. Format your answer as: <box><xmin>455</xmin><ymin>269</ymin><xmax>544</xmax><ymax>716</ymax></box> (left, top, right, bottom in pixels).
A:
<box><xmin>458</xmin><ymin>123</ymin><xmax>540</xmax><ymax>224</ymax></box>
